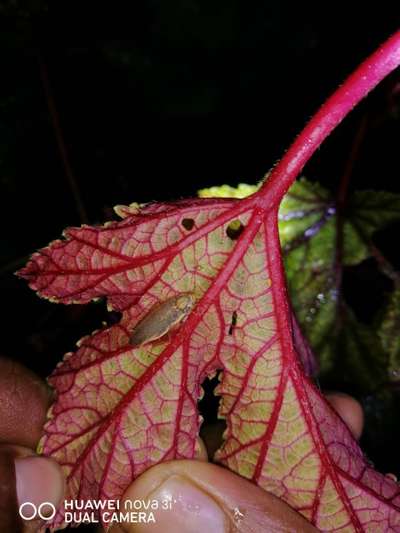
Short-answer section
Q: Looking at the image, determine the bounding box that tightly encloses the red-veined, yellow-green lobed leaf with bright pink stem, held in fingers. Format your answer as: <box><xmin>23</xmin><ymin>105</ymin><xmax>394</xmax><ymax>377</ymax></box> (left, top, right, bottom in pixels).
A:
<box><xmin>19</xmin><ymin>33</ymin><xmax>400</xmax><ymax>532</ymax></box>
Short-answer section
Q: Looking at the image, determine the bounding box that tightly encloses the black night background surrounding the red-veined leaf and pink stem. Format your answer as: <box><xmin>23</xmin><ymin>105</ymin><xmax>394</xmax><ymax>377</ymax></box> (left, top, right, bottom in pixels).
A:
<box><xmin>0</xmin><ymin>0</ymin><xmax>400</xmax><ymax>528</ymax></box>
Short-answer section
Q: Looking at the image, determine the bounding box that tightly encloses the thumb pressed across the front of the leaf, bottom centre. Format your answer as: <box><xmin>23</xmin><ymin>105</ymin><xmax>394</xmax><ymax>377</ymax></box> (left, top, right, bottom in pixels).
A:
<box><xmin>112</xmin><ymin>460</ymin><xmax>316</xmax><ymax>533</ymax></box>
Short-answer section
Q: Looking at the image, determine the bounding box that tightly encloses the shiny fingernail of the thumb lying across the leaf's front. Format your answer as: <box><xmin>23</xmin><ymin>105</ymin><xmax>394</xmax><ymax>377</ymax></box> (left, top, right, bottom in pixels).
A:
<box><xmin>143</xmin><ymin>475</ymin><xmax>228</xmax><ymax>533</ymax></box>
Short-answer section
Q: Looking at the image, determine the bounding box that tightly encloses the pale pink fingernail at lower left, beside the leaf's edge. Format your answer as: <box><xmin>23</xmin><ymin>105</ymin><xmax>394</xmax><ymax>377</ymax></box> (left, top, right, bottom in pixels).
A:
<box><xmin>15</xmin><ymin>457</ymin><xmax>64</xmax><ymax>509</ymax></box>
